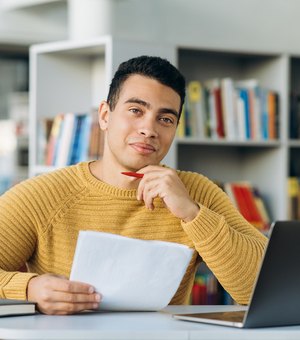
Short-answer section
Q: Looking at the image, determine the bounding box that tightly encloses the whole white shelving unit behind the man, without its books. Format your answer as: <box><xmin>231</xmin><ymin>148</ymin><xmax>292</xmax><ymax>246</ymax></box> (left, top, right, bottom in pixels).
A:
<box><xmin>30</xmin><ymin>36</ymin><xmax>300</xmax><ymax>220</ymax></box>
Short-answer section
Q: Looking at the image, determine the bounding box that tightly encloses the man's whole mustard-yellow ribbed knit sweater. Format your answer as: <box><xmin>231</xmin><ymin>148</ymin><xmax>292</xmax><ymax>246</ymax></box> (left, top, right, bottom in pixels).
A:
<box><xmin>0</xmin><ymin>163</ymin><xmax>266</xmax><ymax>304</ymax></box>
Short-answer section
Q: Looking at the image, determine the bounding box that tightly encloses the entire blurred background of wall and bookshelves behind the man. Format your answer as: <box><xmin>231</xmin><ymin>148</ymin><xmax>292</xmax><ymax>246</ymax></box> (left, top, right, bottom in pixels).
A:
<box><xmin>0</xmin><ymin>0</ymin><xmax>300</xmax><ymax>304</ymax></box>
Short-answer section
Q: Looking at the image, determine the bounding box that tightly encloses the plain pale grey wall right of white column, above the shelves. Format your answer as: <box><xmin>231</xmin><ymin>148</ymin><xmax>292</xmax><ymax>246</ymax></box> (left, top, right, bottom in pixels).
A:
<box><xmin>111</xmin><ymin>0</ymin><xmax>300</xmax><ymax>53</ymax></box>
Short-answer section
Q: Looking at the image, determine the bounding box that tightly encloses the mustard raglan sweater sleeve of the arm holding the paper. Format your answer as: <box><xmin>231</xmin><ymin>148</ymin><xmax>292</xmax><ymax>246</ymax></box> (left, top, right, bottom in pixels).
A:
<box><xmin>0</xmin><ymin>166</ymin><xmax>82</xmax><ymax>300</ymax></box>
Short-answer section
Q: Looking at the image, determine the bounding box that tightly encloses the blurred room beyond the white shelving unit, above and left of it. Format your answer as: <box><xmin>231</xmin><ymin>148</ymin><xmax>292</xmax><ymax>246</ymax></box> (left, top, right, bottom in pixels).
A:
<box><xmin>0</xmin><ymin>0</ymin><xmax>300</xmax><ymax>192</ymax></box>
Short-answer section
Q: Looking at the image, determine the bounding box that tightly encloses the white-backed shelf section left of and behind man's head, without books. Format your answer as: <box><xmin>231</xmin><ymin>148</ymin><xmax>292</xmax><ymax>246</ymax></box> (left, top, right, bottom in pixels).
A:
<box><xmin>29</xmin><ymin>36</ymin><xmax>176</xmax><ymax>176</ymax></box>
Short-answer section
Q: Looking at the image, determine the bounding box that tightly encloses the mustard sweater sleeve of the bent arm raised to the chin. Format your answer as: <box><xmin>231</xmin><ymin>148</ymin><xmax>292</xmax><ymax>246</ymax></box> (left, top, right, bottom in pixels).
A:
<box><xmin>182</xmin><ymin>176</ymin><xmax>267</xmax><ymax>304</ymax></box>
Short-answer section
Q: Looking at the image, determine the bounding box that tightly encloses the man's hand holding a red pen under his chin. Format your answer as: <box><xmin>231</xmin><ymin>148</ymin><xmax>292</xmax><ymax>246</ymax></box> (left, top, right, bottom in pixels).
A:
<box><xmin>137</xmin><ymin>165</ymin><xmax>200</xmax><ymax>222</ymax></box>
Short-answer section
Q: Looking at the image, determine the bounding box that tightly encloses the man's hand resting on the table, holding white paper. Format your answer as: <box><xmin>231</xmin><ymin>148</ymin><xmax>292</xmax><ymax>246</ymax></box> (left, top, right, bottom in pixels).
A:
<box><xmin>27</xmin><ymin>274</ymin><xmax>100</xmax><ymax>315</ymax></box>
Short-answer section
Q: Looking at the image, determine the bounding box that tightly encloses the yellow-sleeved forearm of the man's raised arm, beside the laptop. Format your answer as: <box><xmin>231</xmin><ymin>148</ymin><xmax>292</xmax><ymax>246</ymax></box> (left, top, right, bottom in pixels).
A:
<box><xmin>182</xmin><ymin>206</ymin><xmax>267</xmax><ymax>304</ymax></box>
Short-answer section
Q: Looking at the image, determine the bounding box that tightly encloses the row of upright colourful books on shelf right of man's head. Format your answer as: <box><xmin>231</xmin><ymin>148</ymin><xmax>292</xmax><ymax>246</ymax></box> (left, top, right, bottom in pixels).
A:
<box><xmin>178</xmin><ymin>78</ymin><xmax>279</xmax><ymax>141</ymax></box>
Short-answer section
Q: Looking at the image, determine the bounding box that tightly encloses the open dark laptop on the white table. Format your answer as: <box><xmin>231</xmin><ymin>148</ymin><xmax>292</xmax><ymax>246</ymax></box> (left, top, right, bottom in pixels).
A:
<box><xmin>173</xmin><ymin>221</ymin><xmax>300</xmax><ymax>328</ymax></box>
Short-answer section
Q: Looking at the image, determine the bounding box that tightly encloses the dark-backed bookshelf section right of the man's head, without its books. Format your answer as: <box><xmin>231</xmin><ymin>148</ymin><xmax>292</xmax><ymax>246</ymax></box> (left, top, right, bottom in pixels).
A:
<box><xmin>176</xmin><ymin>47</ymin><xmax>289</xmax><ymax>219</ymax></box>
